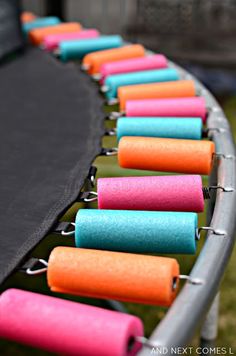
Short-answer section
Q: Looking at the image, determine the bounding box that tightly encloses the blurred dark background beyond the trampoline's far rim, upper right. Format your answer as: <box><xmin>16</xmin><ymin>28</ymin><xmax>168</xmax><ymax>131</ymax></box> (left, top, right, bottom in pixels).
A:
<box><xmin>22</xmin><ymin>0</ymin><xmax>236</xmax><ymax>95</ymax></box>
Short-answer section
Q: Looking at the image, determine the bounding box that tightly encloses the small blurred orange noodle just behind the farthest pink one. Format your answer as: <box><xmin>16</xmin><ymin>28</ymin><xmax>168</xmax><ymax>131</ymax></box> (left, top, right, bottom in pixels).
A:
<box><xmin>29</xmin><ymin>22</ymin><xmax>81</xmax><ymax>46</ymax></box>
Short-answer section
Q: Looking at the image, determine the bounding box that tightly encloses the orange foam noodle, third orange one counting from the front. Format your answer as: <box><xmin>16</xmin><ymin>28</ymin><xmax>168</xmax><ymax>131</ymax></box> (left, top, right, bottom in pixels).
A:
<box><xmin>117</xmin><ymin>80</ymin><xmax>196</xmax><ymax>111</ymax></box>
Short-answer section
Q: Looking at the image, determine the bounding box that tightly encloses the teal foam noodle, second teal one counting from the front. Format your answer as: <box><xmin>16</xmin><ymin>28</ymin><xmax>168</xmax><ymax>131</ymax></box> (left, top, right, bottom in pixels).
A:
<box><xmin>116</xmin><ymin>117</ymin><xmax>203</xmax><ymax>141</ymax></box>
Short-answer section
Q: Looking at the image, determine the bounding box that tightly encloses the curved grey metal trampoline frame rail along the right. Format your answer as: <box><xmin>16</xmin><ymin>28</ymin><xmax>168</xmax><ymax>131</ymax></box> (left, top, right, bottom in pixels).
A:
<box><xmin>139</xmin><ymin>62</ymin><xmax>236</xmax><ymax>356</ymax></box>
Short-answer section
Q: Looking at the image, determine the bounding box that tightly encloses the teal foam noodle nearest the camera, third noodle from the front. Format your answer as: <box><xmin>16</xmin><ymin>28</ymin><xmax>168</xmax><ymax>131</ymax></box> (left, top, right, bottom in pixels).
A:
<box><xmin>75</xmin><ymin>209</ymin><xmax>198</xmax><ymax>254</ymax></box>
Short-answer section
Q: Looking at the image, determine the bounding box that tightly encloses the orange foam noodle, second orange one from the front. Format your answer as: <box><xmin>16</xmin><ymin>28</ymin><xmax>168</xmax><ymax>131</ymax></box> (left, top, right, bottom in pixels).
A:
<box><xmin>118</xmin><ymin>137</ymin><xmax>215</xmax><ymax>174</ymax></box>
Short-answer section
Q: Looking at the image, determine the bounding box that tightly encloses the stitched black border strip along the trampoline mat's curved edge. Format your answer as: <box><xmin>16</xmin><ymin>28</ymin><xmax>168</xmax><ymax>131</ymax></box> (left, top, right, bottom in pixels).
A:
<box><xmin>1</xmin><ymin>58</ymin><xmax>104</xmax><ymax>284</ymax></box>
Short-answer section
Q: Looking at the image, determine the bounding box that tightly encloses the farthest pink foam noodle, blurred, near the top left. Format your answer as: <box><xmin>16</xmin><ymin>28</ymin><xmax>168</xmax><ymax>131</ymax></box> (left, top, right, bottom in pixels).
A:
<box><xmin>43</xmin><ymin>29</ymin><xmax>100</xmax><ymax>51</ymax></box>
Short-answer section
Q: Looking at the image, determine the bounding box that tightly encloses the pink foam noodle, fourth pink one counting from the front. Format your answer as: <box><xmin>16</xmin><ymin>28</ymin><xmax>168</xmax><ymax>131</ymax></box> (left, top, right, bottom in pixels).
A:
<box><xmin>100</xmin><ymin>54</ymin><xmax>168</xmax><ymax>84</ymax></box>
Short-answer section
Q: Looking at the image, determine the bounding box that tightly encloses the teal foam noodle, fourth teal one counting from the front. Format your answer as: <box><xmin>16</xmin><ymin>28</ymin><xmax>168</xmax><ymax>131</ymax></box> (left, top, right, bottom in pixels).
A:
<box><xmin>59</xmin><ymin>35</ymin><xmax>123</xmax><ymax>62</ymax></box>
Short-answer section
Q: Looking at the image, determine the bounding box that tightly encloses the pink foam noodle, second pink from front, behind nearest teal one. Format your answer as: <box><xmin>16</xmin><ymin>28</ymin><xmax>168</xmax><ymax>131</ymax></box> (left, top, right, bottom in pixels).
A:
<box><xmin>97</xmin><ymin>175</ymin><xmax>204</xmax><ymax>212</ymax></box>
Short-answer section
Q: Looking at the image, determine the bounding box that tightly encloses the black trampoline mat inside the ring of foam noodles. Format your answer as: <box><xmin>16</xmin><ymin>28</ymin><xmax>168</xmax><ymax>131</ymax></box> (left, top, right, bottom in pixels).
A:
<box><xmin>0</xmin><ymin>49</ymin><xmax>104</xmax><ymax>283</ymax></box>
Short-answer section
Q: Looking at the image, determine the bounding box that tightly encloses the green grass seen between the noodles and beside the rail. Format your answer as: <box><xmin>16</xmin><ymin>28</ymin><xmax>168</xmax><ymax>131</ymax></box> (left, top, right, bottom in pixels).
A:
<box><xmin>0</xmin><ymin>96</ymin><xmax>236</xmax><ymax>356</ymax></box>
